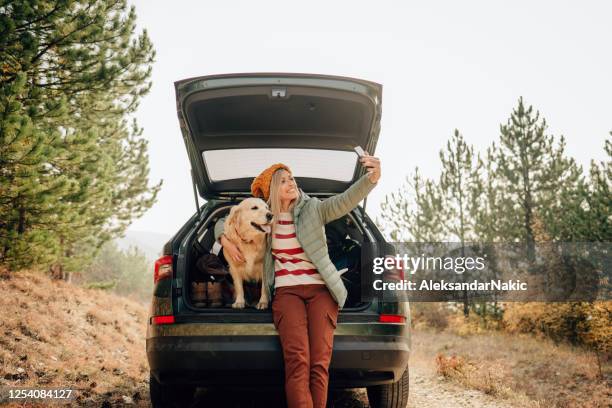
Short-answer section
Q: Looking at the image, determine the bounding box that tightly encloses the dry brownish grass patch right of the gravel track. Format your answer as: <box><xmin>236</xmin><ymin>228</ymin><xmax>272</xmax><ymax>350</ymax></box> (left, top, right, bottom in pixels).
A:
<box><xmin>413</xmin><ymin>329</ymin><xmax>612</xmax><ymax>407</ymax></box>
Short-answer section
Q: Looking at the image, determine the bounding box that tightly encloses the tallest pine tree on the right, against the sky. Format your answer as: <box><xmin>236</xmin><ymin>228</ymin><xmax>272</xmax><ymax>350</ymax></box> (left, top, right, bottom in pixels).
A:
<box><xmin>495</xmin><ymin>98</ymin><xmax>581</xmax><ymax>255</ymax></box>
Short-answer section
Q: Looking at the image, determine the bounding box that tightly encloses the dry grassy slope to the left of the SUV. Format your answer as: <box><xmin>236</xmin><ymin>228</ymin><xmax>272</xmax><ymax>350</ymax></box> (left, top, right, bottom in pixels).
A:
<box><xmin>0</xmin><ymin>271</ymin><xmax>148</xmax><ymax>406</ymax></box>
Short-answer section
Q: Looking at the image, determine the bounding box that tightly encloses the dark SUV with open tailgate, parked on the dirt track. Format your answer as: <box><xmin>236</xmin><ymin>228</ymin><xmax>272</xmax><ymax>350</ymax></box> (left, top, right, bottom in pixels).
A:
<box><xmin>147</xmin><ymin>74</ymin><xmax>410</xmax><ymax>408</ymax></box>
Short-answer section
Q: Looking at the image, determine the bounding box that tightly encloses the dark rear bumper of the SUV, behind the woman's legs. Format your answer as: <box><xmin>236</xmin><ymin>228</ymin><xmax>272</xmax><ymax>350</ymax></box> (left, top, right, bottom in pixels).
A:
<box><xmin>147</xmin><ymin>330</ymin><xmax>410</xmax><ymax>388</ymax></box>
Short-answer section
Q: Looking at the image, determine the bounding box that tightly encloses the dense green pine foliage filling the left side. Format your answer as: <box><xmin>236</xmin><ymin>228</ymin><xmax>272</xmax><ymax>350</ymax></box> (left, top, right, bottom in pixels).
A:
<box><xmin>0</xmin><ymin>0</ymin><xmax>161</xmax><ymax>271</ymax></box>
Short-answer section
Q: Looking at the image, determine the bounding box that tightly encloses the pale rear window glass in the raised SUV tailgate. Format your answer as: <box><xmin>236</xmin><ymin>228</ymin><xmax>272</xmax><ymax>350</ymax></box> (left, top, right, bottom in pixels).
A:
<box><xmin>203</xmin><ymin>149</ymin><xmax>357</xmax><ymax>182</ymax></box>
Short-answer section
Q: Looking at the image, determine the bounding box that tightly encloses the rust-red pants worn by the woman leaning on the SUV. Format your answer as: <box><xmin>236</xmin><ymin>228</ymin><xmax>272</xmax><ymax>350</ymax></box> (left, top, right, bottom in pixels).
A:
<box><xmin>272</xmin><ymin>284</ymin><xmax>338</xmax><ymax>408</ymax></box>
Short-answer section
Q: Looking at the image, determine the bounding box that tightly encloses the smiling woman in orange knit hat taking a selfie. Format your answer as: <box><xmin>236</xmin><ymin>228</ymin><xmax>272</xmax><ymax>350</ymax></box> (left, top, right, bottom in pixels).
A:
<box><xmin>215</xmin><ymin>153</ymin><xmax>380</xmax><ymax>408</ymax></box>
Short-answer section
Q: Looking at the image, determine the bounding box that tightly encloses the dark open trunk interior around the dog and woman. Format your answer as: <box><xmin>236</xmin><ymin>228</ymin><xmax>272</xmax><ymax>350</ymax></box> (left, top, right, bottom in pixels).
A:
<box><xmin>183</xmin><ymin>204</ymin><xmax>369</xmax><ymax>313</ymax></box>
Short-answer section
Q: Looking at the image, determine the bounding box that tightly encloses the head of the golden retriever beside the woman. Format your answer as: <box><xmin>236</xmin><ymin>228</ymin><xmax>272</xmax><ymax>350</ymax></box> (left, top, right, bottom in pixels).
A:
<box><xmin>228</xmin><ymin>198</ymin><xmax>273</xmax><ymax>240</ymax></box>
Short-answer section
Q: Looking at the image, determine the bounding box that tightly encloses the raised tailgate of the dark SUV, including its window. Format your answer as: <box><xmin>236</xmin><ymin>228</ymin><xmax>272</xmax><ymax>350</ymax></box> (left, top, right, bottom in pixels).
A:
<box><xmin>175</xmin><ymin>73</ymin><xmax>382</xmax><ymax>199</ymax></box>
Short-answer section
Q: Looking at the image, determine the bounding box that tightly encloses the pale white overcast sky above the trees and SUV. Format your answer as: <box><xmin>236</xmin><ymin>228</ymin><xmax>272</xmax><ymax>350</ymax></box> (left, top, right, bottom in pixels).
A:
<box><xmin>128</xmin><ymin>0</ymin><xmax>612</xmax><ymax>235</ymax></box>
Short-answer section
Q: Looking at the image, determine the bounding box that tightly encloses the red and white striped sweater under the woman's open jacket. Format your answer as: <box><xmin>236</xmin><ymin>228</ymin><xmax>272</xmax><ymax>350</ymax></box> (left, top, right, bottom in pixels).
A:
<box><xmin>272</xmin><ymin>212</ymin><xmax>325</xmax><ymax>287</ymax></box>
